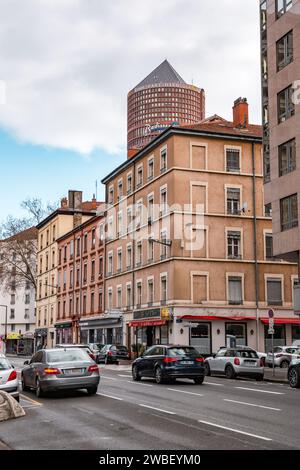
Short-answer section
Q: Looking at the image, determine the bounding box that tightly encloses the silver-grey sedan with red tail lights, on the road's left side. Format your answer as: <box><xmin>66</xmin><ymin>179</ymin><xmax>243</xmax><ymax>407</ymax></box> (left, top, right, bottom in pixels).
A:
<box><xmin>21</xmin><ymin>347</ymin><xmax>100</xmax><ymax>397</ymax></box>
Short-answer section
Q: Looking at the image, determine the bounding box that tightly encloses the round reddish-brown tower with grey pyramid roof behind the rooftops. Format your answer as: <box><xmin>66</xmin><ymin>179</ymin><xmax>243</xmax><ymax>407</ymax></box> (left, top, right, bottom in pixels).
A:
<box><xmin>127</xmin><ymin>59</ymin><xmax>205</xmax><ymax>152</ymax></box>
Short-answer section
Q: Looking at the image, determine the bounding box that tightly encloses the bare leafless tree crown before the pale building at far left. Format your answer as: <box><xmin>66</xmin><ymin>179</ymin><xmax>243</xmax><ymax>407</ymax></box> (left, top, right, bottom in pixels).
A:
<box><xmin>0</xmin><ymin>199</ymin><xmax>57</xmax><ymax>290</ymax></box>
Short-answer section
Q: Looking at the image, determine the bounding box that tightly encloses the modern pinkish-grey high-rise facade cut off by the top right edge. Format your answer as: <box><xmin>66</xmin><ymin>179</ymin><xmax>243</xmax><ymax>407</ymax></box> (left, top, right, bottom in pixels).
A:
<box><xmin>260</xmin><ymin>0</ymin><xmax>300</xmax><ymax>268</ymax></box>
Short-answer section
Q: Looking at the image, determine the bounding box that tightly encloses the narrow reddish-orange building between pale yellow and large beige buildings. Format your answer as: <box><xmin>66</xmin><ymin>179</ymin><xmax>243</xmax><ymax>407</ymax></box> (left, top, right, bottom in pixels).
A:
<box><xmin>54</xmin><ymin>215</ymin><xmax>106</xmax><ymax>344</ymax></box>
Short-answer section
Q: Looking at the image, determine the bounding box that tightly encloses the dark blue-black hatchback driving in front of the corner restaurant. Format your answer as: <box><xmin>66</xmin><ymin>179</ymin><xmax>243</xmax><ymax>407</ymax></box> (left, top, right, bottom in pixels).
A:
<box><xmin>132</xmin><ymin>345</ymin><xmax>204</xmax><ymax>384</ymax></box>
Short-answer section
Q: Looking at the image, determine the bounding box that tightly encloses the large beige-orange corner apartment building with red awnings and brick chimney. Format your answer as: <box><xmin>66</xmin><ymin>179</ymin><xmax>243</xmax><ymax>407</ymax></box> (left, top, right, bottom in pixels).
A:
<box><xmin>103</xmin><ymin>98</ymin><xmax>299</xmax><ymax>354</ymax></box>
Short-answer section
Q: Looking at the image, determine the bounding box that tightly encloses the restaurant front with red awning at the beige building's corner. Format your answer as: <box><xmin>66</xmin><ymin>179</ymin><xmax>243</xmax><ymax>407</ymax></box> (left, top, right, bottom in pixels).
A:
<box><xmin>127</xmin><ymin>307</ymin><xmax>173</xmax><ymax>354</ymax></box>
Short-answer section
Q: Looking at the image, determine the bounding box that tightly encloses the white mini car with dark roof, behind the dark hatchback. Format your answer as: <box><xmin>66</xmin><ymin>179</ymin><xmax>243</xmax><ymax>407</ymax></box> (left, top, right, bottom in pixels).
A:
<box><xmin>204</xmin><ymin>346</ymin><xmax>264</xmax><ymax>380</ymax></box>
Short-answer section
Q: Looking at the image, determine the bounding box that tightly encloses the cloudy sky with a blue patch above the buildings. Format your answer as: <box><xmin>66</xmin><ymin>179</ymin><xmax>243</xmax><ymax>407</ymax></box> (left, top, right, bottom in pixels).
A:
<box><xmin>0</xmin><ymin>0</ymin><xmax>260</xmax><ymax>219</ymax></box>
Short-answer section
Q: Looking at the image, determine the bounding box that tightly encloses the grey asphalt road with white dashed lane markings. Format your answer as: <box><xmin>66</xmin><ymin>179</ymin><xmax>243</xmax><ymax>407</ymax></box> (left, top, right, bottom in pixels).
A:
<box><xmin>0</xmin><ymin>360</ymin><xmax>300</xmax><ymax>450</ymax></box>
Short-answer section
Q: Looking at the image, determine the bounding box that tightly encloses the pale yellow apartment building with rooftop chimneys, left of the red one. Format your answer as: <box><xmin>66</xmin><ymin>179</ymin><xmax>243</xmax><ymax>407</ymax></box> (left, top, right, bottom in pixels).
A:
<box><xmin>35</xmin><ymin>191</ymin><xmax>97</xmax><ymax>349</ymax></box>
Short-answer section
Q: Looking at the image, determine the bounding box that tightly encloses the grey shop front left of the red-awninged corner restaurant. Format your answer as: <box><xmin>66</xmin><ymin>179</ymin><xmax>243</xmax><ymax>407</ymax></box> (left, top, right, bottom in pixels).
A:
<box><xmin>79</xmin><ymin>313</ymin><xmax>123</xmax><ymax>345</ymax></box>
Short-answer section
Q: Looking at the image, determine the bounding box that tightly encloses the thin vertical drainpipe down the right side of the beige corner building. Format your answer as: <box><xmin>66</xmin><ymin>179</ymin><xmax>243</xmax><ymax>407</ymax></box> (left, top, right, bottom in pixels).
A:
<box><xmin>252</xmin><ymin>142</ymin><xmax>260</xmax><ymax>351</ymax></box>
